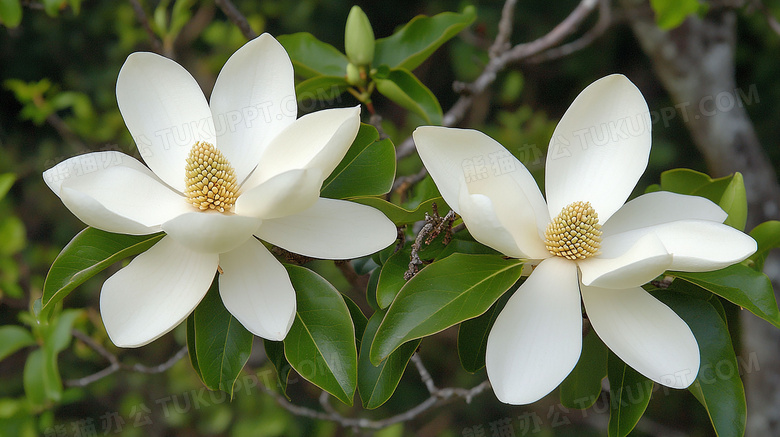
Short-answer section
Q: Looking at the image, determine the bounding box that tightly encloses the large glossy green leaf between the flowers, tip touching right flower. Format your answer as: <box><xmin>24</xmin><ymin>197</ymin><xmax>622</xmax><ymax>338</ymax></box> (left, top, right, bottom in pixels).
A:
<box><xmin>370</xmin><ymin>253</ymin><xmax>523</xmax><ymax>364</ymax></box>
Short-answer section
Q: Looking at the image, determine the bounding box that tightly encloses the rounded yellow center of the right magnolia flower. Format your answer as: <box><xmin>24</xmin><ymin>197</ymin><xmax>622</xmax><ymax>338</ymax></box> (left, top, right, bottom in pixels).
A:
<box><xmin>544</xmin><ymin>201</ymin><xmax>601</xmax><ymax>260</ymax></box>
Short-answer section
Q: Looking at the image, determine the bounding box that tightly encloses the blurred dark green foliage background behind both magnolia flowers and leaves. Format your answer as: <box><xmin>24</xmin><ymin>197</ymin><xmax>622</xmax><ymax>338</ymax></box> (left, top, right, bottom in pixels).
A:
<box><xmin>0</xmin><ymin>0</ymin><xmax>780</xmax><ymax>437</ymax></box>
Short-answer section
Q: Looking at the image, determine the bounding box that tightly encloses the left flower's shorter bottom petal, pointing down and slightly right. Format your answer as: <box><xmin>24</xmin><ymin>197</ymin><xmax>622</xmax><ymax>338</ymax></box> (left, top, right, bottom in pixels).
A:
<box><xmin>219</xmin><ymin>238</ymin><xmax>296</xmax><ymax>341</ymax></box>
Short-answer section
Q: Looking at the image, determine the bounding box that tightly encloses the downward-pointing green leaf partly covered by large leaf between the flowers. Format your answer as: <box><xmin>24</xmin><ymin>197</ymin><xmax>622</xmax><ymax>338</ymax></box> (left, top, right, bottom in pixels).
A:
<box><xmin>358</xmin><ymin>312</ymin><xmax>420</xmax><ymax>409</ymax></box>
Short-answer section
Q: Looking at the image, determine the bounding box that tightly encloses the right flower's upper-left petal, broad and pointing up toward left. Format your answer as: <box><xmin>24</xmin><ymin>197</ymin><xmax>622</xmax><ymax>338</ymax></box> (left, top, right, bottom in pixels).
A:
<box><xmin>412</xmin><ymin>126</ymin><xmax>550</xmax><ymax>250</ymax></box>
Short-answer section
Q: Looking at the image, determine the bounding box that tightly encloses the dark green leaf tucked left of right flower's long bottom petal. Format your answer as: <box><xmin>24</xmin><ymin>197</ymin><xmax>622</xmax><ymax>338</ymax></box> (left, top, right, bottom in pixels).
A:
<box><xmin>458</xmin><ymin>290</ymin><xmax>514</xmax><ymax>373</ymax></box>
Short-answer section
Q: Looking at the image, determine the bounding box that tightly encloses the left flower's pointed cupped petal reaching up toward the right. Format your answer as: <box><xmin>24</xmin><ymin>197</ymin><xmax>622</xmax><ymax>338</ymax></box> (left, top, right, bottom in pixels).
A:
<box><xmin>244</xmin><ymin>106</ymin><xmax>360</xmax><ymax>189</ymax></box>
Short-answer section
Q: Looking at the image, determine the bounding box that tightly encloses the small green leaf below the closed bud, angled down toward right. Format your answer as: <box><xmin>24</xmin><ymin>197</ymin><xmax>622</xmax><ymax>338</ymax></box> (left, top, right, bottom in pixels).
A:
<box><xmin>372</xmin><ymin>68</ymin><xmax>442</xmax><ymax>126</ymax></box>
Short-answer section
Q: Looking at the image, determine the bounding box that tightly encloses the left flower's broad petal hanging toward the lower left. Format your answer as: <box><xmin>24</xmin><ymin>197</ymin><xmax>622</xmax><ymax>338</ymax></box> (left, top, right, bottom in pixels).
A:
<box><xmin>100</xmin><ymin>237</ymin><xmax>218</xmax><ymax>347</ymax></box>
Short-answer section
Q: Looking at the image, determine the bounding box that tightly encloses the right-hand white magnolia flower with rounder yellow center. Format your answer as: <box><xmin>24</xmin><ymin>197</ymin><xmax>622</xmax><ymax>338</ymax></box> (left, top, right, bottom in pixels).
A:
<box><xmin>414</xmin><ymin>75</ymin><xmax>756</xmax><ymax>404</ymax></box>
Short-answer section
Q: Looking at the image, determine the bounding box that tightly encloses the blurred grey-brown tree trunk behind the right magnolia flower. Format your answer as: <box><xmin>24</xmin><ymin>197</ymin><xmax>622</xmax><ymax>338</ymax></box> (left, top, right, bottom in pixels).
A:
<box><xmin>623</xmin><ymin>0</ymin><xmax>780</xmax><ymax>436</ymax></box>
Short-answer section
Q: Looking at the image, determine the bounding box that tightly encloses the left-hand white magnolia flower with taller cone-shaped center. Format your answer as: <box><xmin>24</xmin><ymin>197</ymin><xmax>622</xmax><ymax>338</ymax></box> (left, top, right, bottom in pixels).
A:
<box><xmin>44</xmin><ymin>34</ymin><xmax>396</xmax><ymax>347</ymax></box>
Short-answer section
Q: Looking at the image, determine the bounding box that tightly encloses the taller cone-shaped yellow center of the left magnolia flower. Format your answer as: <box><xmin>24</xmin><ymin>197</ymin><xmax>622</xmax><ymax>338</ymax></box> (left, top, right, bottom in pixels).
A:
<box><xmin>184</xmin><ymin>141</ymin><xmax>238</xmax><ymax>212</ymax></box>
